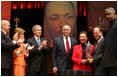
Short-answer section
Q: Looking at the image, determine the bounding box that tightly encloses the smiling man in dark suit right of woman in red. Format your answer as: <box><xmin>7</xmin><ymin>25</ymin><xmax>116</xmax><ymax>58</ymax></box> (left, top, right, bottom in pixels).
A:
<box><xmin>92</xmin><ymin>26</ymin><xmax>105</xmax><ymax>76</ymax></box>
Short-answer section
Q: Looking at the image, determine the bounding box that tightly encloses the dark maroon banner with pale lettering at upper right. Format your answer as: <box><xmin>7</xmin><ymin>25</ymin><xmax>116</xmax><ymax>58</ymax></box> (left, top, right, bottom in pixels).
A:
<box><xmin>87</xmin><ymin>1</ymin><xmax>117</xmax><ymax>32</ymax></box>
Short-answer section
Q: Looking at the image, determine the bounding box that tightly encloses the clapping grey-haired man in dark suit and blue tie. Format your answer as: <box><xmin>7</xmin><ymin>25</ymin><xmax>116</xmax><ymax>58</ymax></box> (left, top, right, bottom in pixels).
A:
<box><xmin>26</xmin><ymin>25</ymin><xmax>49</xmax><ymax>76</ymax></box>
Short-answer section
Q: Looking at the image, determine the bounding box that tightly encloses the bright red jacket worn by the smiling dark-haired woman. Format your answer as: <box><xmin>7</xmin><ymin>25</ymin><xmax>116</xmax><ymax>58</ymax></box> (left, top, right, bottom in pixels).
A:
<box><xmin>72</xmin><ymin>44</ymin><xmax>94</xmax><ymax>72</ymax></box>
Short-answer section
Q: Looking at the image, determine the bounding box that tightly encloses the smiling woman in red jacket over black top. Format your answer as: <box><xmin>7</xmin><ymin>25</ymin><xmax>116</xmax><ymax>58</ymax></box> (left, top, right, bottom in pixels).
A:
<box><xmin>72</xmin><ymin>31</ymin><xmax>94</xmax><ymax>73</ymax></box>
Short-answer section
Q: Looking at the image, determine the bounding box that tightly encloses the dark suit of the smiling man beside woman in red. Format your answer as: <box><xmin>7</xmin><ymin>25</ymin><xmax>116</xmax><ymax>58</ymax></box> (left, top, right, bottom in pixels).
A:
<box><xmin>93</xmin><ymin>38</ymin><xmax>104</xmax><ymax>76</ymax></box>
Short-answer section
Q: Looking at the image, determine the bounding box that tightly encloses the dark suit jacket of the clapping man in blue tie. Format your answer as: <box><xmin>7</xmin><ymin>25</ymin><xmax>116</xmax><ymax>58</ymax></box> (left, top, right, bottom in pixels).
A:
<box><xmin>26</xmin><ymin>37</ymin><xmax>50</xmax><ymax>72</ymax></box>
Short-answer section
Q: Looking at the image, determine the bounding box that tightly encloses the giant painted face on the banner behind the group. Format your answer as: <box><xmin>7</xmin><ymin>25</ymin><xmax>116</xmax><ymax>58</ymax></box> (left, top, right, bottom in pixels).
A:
<box><xmin>44</xmin><ymin>1</ymin><xmax>76</xmax><ymax>39</ymax></box>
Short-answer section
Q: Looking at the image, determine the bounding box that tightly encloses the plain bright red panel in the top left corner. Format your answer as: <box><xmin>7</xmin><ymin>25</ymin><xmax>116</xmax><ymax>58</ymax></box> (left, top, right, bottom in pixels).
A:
<box><xmin>1</xmin><ymin>1</ymin><xmax>11</xmax><ymax>21</ymax></box>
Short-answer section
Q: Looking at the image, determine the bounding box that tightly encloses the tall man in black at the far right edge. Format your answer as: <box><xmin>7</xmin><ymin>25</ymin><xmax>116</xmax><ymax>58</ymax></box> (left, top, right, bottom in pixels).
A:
<box><xmin>102</xmin><ymin>7</ymin><xmax>117</xmax><ymax>76</ymax></box>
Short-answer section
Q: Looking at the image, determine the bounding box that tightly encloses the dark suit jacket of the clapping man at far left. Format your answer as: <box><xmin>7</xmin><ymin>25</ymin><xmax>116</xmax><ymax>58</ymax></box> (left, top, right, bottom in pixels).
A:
<box><xmin>1</xmin><ymin>31</ymin><xmax>18</xmax><ymax>69</ymax></box>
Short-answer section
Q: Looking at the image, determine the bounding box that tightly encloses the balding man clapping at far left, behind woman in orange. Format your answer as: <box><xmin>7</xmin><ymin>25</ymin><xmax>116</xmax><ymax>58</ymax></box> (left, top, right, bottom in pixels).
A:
<box><xmin>1</xmin><ymin>20</ymin><xmax>18</xmax><ymax>76</ymax></box>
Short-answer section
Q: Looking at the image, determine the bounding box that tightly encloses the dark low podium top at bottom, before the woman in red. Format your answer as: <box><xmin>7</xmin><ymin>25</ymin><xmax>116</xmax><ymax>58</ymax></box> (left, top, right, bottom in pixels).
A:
<box><xmin>56</xmin><ymin>70</ymin><xmax>92</xmax><ymax>76</ymax></box>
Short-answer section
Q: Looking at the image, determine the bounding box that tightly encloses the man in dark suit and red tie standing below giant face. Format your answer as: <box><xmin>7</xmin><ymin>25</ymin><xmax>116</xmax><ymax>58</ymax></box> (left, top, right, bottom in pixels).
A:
<box><xmin>52</xmin><ymin>25</ymin><xmax>77</xmax><ymax>73</ymax></box>
